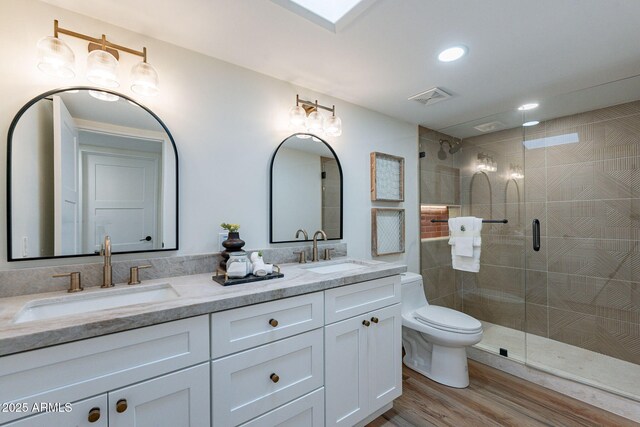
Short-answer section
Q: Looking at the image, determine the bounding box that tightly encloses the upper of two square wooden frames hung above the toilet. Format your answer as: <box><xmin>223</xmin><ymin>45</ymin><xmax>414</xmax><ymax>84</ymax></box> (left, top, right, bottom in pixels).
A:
<box><xmin>371</xmin><ymin>152</ymin><xmax>404</xmax><ymax>202</ymax></box>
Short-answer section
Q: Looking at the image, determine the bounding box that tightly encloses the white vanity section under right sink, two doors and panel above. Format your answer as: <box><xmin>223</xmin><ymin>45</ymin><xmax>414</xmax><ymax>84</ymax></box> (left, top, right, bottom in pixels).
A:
<box><xmin>325</xmin><ymin>276</ymin><xmax>402</xmax><ymax>426</ymax></box>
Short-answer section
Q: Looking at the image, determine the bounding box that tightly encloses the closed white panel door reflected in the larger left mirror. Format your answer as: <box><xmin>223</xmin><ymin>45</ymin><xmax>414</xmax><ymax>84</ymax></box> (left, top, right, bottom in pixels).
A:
<box><xmin>83</xmin><ymin>152</ymin><xmax>162</xmax><ymax>252</ymax></box>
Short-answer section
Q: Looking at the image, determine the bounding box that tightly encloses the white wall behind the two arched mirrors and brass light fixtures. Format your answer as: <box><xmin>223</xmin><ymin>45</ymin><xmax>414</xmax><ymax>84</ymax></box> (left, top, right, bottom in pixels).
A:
<box><xmin>0</xmin><ymin>0</ymin><xmax>419</xmax><ymax>272</ymax></box>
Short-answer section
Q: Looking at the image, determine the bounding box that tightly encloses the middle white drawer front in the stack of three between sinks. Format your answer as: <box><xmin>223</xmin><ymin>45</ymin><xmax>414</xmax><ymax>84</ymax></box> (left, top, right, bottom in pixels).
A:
<box><xmin>211</xmin><ymin>329</ymin><xmax>324</xmax><ymax>426</ymax></box>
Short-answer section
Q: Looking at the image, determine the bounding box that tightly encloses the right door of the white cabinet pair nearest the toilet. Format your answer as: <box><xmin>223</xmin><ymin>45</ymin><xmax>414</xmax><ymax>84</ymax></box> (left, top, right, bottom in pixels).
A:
<box><xmin>367</xmin><ymin>304</ymin><xmax>402</xmax><ymax>413</ymax></box>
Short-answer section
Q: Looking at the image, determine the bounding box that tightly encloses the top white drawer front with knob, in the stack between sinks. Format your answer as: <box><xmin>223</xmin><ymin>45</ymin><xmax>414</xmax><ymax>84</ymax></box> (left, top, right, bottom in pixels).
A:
<box><xmin>211</xmin><ymin>292</ymin><xmax>324</xmax><ymax>359</ymax></box>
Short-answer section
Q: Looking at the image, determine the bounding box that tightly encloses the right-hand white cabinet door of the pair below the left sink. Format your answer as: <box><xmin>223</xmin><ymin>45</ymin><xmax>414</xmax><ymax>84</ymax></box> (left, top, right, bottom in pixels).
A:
<box><xmin>109</xmin><ymin>363</ymin><xmax>210</xmax><ymax>427</ymax></box>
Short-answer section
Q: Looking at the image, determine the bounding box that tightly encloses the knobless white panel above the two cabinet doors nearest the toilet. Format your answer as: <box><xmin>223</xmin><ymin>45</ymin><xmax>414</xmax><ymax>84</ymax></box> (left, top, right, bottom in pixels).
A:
<box><xmin>324</xmin><ymin>275</ymin><xmax>400</xmax><ymax>325</ymax></box>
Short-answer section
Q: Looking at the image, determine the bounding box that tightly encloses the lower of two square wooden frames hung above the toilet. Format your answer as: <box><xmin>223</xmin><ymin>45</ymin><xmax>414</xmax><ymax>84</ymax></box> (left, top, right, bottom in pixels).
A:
<box><xmin>371</xmin><ymin>208</ymin><xmax>405</xmax><ymax>256</ymax></box>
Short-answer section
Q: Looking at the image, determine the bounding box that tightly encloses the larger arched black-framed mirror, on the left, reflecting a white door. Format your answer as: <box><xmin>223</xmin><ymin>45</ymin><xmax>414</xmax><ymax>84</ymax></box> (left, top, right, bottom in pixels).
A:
<box><xmin>7</xmin><ymin>87</ymin><xmax>178</xmax><ymax>261</ymax></box>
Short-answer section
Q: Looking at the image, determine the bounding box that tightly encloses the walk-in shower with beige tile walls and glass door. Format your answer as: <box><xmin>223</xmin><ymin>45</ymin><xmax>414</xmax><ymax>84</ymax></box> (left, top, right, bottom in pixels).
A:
<box><xmin>420</xmin><ymin>77</ymin><xmax>640</xmax><ymax>401</ymax></box>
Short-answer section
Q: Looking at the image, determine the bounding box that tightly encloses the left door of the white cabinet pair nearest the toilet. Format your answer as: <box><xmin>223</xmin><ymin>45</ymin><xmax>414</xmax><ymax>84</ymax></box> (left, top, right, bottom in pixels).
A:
<box><xmin>324</xmin><ymin>315</ymin><xmax>370</xmax><ymax>426</ymax></box>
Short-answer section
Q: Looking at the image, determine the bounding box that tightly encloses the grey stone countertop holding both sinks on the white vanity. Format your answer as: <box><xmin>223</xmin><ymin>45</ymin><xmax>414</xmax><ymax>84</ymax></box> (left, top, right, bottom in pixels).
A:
<box><xmin>0</xmin><ymin>259</ymin><xmax>407</xmax><ymax>356</ymax></box>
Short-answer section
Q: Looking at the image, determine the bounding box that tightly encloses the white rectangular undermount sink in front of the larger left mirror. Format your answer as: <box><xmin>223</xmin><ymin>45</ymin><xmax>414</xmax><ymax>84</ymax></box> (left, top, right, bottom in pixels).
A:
<box><xmin>13</xmin><ymin>283</ymin><xmax>180</xmax><ymax>323</ymax></box>
